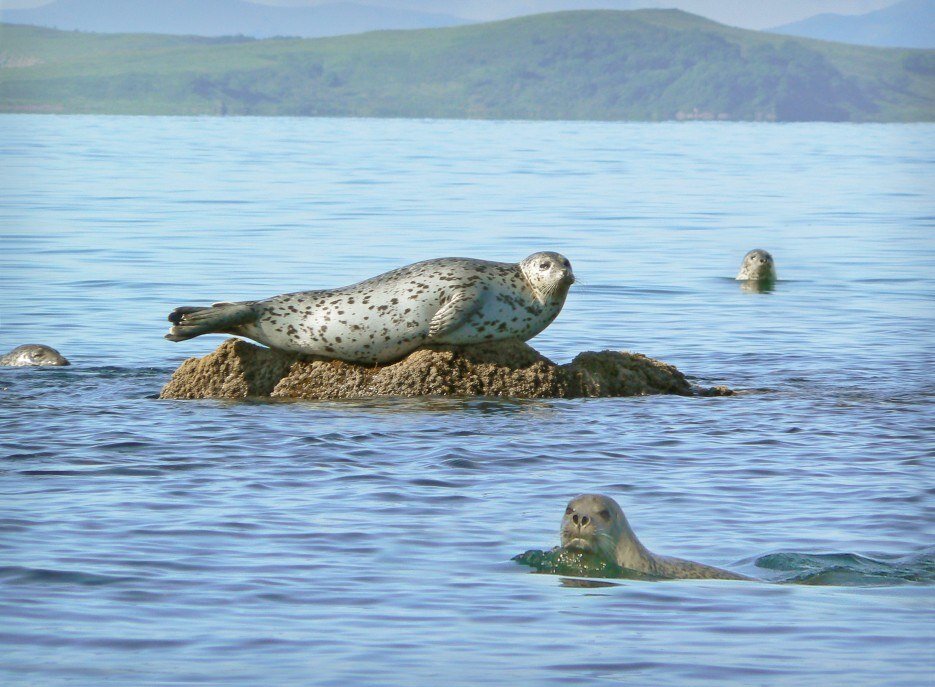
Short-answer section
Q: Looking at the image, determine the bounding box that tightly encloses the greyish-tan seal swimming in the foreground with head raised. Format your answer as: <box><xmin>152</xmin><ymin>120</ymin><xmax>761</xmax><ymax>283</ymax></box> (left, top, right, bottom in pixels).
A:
<box><xmin>561</xmin><ymin>494</ymin><xmax>751</xmax><ymax>580</ymax></box>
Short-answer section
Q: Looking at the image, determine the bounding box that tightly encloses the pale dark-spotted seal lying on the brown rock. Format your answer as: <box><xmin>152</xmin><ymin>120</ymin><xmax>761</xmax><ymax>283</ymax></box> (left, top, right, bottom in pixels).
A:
<box><xmin>166</xmin><ymin>252</ymin><xmax>575</xmax><ymax>363</ymax></box>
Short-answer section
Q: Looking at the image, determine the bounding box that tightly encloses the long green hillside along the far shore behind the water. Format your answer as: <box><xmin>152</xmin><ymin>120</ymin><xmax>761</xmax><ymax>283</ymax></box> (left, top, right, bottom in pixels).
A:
<box><xmin>0</xmin><ymin>10</ymin><xmax>935</xmax><ymax>121</ymax></box>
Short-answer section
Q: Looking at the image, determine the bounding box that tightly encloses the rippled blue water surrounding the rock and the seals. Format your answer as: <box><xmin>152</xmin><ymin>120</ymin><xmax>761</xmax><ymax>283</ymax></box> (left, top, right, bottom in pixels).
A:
<box><xmin>0</xmin><ymin>115</ymin><xmax>935</xmax><ymax>687</ymax></box>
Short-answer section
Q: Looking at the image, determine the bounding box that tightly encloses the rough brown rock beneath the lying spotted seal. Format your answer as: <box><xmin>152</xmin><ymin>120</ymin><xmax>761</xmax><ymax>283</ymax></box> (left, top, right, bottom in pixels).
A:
<box><xmin>160</xmin><ymin>339</ymin><xmax>730</xmax><ymax>400</ymax></box>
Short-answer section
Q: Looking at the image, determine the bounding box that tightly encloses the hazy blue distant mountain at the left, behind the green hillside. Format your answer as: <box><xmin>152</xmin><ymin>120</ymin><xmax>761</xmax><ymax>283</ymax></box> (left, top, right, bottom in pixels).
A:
<box><xmin>0</xmin><ymin>0</ymin><xmax>468</xmax><ymax>38</ymax></box>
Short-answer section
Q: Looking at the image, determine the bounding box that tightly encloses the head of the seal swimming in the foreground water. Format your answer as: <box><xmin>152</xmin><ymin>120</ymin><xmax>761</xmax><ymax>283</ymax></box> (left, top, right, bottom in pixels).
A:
<box><xmin>561</xmin><ymin>494</ymin><xmax>630</xmax><ymax>561</ymax></box>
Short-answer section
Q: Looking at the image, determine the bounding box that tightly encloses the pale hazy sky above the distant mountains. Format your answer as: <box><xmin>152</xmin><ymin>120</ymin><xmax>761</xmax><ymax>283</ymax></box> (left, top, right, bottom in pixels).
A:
<box><xmin>0</xmin><ymin>0</ymin><xmax>897</xmax><ymax>29</ymax></box>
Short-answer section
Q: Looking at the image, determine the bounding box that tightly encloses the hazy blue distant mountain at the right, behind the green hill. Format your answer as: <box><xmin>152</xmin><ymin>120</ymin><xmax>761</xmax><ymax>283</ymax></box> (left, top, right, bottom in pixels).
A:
<box><xmin>769</xmin><ymin>0</ymin><xmax>935</xmax><ymax>48</ymax></box>
